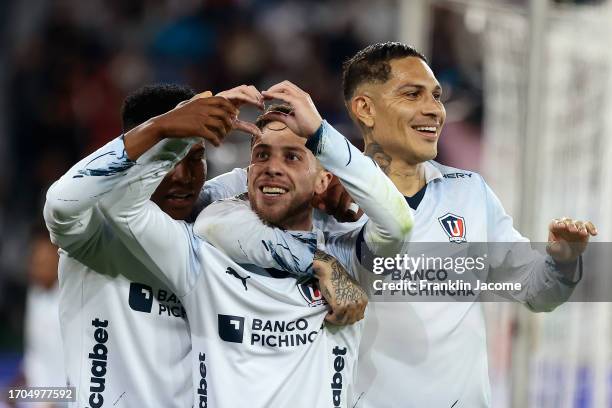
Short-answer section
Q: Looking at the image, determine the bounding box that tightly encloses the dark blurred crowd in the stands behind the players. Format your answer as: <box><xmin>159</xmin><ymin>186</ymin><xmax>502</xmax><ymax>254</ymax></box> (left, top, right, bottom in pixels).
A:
<box><xmin>0</xmin><ymin>0</ymin><xmax>482</xmax><ymax>392</ymax></box>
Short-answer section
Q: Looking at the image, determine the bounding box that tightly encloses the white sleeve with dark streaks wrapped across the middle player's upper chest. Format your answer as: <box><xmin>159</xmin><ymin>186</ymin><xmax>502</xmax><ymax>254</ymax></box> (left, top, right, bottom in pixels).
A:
<box><xmin>193</xmin><ymin>194</ymin><xmax>317</xmax><ymax>281</ymax></box>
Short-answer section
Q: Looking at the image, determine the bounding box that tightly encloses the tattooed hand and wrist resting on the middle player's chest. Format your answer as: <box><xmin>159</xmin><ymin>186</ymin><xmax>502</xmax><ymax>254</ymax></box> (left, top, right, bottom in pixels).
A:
<box><xmin>312</xmin><ymin>249</ymin><xmax>368</xmax><ymax>325</ymax></box>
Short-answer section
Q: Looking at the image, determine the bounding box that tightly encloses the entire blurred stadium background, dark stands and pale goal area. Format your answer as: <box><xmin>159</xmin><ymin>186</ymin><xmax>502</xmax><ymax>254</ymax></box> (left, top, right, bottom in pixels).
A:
<box><xmin>0</xmin><ymin>0</ymin><xmax>612</xmax><ymax>408</ymax></box>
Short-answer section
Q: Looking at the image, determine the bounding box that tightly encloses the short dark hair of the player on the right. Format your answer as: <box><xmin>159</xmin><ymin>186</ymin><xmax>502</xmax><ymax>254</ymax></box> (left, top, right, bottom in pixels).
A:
<box><xmin>342</xmin><ymin>41</ymin><xmax>427</xmax><ymax>101</ymax></box>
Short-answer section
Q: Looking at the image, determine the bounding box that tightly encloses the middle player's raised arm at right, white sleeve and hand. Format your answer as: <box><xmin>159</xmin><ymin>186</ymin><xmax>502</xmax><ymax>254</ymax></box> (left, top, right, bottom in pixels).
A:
<box><xmin>262</xmin><ymin>81</ymin><xmax>413</xmax><ymax>255</ymax></box>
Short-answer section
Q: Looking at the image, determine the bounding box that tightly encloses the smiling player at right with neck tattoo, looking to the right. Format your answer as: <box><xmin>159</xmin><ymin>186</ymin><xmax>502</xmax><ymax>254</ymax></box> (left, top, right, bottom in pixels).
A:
<box><xmin>343</xmin><ymin>42</ymin><xmax>597</xmax><ymax>408</ymax></box>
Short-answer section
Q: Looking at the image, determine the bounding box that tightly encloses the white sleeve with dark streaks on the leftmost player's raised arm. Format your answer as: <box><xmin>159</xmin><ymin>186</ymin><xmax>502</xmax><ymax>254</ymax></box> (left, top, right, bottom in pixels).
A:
<box><xmin>43</xmin><ymin>137</ymin><xmax>135</xmax><ymax>252</ymax></box>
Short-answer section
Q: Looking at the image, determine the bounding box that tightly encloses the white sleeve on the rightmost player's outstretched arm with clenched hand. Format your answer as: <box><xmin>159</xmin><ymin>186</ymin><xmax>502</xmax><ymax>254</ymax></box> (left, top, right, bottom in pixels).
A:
<box><xmin>483</xmin><ymin>177</ymin><xmax>582</xmax><ymax>312</ymax></box>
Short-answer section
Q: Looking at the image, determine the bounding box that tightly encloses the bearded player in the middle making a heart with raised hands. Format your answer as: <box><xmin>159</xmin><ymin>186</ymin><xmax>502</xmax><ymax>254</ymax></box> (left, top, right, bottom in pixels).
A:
<box><xmin>95</xmin><ymin>84</ymin><xmax>412</xmax><ymax>407</ymax></box>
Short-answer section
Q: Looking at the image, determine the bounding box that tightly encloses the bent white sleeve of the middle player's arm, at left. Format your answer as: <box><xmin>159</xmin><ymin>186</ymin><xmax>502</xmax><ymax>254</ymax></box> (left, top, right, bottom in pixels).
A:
<box><xmin>100</xmin><ymin>139</ymin><xmax>201</xmax><ymax>296</ymax></box>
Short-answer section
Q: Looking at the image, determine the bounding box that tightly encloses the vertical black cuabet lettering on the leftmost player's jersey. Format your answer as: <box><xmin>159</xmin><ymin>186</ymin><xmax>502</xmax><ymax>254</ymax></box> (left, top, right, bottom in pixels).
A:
<box><xmin>88</xmin><ymin>317</ymin><xmax>108</xmax><ymax>408</ymax></box>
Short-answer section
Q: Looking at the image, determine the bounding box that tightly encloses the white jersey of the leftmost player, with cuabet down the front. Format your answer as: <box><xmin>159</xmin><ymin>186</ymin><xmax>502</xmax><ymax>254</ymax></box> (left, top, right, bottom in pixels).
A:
<box><xmin>44</xmin><ymin>139</ymin><xmax>192</xmax><ymax>408</ymax></box>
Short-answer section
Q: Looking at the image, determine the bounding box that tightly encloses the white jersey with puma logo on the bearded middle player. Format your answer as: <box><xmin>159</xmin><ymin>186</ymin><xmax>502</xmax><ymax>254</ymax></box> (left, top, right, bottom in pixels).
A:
<box><xmin>97</xmin><ymin>121</ymin><xmax>412</xmax><ymax>407</ymax></box>
